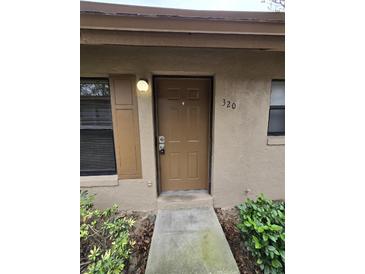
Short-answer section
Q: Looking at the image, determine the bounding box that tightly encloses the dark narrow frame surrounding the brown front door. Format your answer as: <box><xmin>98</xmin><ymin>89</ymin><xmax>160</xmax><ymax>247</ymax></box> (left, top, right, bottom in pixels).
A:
<box><xmin>152</xmin><ymin>74</ymin><xmax>214</xmax><ymax>196</ymax></box>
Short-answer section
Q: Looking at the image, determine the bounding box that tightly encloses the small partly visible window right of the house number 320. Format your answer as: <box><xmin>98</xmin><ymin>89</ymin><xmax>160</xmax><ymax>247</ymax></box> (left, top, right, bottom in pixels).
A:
<box><xmin>268</xmin><ymin>80</ymin><xmax>285</xmax><ymax>135</ymax></box>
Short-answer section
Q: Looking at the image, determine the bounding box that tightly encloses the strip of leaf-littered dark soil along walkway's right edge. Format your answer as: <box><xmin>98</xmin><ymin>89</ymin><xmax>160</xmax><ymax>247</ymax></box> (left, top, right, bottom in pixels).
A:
<box><xmin>215</xmin><ymin>208</ymin><xmax>262</xmax><ymax>274</ymax></box>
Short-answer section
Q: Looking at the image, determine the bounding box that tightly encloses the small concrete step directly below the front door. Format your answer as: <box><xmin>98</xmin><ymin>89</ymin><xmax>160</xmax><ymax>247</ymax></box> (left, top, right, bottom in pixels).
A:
<box><xmin>157</xmin><ymin>190</ymin><xmax>213</xmax><ymax>209</ymax></box>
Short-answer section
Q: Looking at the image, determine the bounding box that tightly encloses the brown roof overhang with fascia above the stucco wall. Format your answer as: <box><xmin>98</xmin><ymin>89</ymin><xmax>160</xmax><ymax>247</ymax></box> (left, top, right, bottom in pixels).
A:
<box><xmin>80</xmin><ymin>2</ymin><xmax>285</xmax><ymax>51</ymax></box>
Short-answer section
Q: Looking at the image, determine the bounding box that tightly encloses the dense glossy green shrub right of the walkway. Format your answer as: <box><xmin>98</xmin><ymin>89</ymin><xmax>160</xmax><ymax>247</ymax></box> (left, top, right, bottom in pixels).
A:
<box><xmin>237</xmin><ymin>194</ymin><xmax>285</xmax><ymax>274</ymax></box>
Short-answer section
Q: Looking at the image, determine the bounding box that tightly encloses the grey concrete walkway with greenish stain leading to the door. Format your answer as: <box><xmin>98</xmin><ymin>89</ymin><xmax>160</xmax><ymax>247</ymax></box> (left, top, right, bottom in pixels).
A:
<box><xmin>146</xmin><ymin>207</ymin><xmax>239</xmax><ymax>274</ymax></box>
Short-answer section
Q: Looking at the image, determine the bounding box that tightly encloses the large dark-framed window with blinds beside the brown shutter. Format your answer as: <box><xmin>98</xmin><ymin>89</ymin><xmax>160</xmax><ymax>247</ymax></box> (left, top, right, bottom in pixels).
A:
<box><xmin>80</xmin><ymin>78</ymin><xmax>116</xmax><ymax>176</ymax></box>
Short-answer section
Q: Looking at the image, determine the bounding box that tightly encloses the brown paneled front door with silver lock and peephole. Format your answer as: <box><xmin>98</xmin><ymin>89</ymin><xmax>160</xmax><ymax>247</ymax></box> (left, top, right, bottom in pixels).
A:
<box><xmin>155</xmin><ymin>77</ymin><xmax>211</xmax><ymax>191</ymax></box>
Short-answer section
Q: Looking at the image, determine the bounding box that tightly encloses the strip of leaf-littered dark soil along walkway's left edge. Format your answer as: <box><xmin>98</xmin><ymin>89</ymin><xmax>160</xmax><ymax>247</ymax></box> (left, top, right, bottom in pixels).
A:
<box><xmin>121</xmin><ymin>212</ymin><xmax>156</xmax><ymax>274</ymax></box>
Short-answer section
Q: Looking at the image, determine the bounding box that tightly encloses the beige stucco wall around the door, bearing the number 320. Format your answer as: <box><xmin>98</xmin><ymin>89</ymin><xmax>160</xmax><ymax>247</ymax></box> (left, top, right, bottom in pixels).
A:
<box><xmin>80</xmin><ymin>46</ymin><xmax>284</xmax><ymax>210</ymax></box>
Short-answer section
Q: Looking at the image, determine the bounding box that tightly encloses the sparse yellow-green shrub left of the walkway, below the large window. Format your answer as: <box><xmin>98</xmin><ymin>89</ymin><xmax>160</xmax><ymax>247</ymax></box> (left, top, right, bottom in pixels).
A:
<box><xmin>80</xmin><ymin>191</ymin><xmax>134</xmax><ymax>274</ymax></box>
